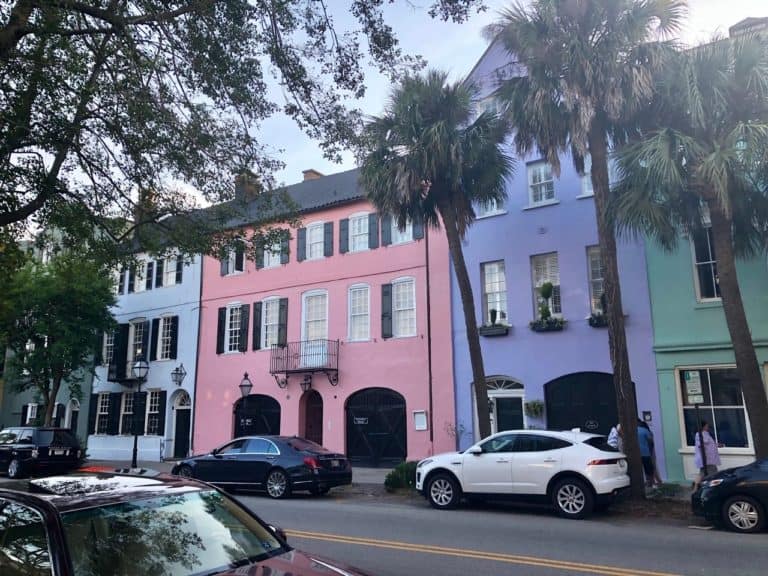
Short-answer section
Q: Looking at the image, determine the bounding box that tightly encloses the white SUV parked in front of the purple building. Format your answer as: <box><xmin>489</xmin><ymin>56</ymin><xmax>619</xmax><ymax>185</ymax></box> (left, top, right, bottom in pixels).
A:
<box><xmin>416</xmin><ymin>430</ymin><xmax>629</xmax><ymax>518</ymax></box>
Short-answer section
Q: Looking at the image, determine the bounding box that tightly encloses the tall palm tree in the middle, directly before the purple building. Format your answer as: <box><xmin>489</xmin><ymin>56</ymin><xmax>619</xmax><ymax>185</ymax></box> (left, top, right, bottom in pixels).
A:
<box><xmin>487</xmin><ymin>0</ymin><xmax>685</xmax><ymax>497</ymax></box>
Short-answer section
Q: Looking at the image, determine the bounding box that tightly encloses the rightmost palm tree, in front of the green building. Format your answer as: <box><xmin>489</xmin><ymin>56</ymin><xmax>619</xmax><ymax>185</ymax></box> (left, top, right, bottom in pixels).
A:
<box><xmin>612</xmin><ymin>37</ymin><xmax>768</xmax><ymax>458</ymax></box>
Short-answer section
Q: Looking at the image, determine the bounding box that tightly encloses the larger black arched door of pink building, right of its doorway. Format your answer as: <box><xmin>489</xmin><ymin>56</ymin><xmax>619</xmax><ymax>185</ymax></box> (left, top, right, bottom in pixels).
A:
<box><xmin>346</xmin><ymin>388</ymin><xmax>408</xmax><ymax>466</ymax></box>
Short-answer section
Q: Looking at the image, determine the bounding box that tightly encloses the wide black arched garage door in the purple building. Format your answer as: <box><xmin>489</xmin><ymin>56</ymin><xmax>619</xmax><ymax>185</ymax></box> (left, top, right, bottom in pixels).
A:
<box><xmin>544</xmin><ymin>372</ymin><xmax>632</xmax><ymax>434</ymax></box>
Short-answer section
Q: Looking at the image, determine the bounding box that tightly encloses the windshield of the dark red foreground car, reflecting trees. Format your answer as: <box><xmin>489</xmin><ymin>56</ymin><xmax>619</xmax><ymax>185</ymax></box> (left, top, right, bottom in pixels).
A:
<box><xmin>62</xmin><ymin>490</ymin><xmax>288</xmax><ymax>576</ymax></box>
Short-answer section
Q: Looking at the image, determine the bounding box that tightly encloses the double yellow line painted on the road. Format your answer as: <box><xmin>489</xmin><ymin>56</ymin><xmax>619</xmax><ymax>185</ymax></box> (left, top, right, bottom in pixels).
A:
<box><xmin>285</xmin><ymin>530</ymin><xmax>677</xmax><ymax>576</ymax></box>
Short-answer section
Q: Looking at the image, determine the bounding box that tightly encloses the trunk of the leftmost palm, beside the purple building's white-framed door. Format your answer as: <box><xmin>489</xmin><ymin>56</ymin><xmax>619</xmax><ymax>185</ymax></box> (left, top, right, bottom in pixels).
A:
<box><xmin>440</xmin><ymin>207</ymin><xmax>491</xmax><ymax>442</ymax></box>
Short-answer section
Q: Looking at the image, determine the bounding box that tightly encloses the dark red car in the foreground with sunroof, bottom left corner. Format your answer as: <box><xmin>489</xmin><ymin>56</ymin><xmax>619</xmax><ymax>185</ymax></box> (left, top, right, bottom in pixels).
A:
<box><xmin>0</xmin><ymin>473</ymin><xmax>374</xmax><ymax>576</ymax></box>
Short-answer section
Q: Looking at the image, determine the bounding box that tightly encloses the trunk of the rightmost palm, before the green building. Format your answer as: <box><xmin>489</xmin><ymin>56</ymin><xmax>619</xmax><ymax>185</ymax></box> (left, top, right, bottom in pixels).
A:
<box><xmin>709</xmin><ymin>207</ymin><xmax>768</xmax><ymax>459</ymax></box>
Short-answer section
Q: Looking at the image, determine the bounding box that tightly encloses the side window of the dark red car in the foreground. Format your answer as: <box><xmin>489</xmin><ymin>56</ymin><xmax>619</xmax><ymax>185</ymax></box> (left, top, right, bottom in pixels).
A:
<box><xmin>0</xmin><ymin>498</ymin><xmax>51</xmax><ymax>576</ymax></box>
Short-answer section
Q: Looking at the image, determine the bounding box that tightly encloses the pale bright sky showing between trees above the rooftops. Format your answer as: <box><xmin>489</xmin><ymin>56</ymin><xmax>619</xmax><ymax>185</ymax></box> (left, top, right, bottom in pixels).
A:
<box><xmin>259</xmin><ymin>0</ymin><xmax>768</xmax><ymax>184</ymax></box>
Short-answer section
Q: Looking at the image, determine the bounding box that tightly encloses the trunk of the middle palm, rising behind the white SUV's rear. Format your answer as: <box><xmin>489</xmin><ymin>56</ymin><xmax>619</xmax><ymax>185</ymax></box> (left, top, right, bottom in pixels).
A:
<box><xmin>589</xmin><ymin>120</ymin><xmax>645</xmax><ymax>499</ymax></box>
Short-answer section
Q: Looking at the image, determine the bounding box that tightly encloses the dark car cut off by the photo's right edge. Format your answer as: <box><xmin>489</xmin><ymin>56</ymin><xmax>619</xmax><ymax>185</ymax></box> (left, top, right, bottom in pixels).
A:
<box><xmin>691</xmin><ymin>459</ymin><xmax>768</xmax><ymax>532</ymax></box>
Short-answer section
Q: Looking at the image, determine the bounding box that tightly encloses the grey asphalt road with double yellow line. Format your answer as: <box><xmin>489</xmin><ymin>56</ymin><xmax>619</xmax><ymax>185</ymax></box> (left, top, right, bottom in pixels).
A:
<box><xmin>241</xmin><ymin>494</ymin><xmax>768</xmax><ymax>576</ymax></box>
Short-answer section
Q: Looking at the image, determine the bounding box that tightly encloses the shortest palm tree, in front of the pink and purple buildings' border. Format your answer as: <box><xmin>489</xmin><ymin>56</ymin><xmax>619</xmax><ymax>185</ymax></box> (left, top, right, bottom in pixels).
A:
<box><xmin>360</xmin><ymin>70</ymin><xmax>514</xmax><ymax>438</ymax></box>
